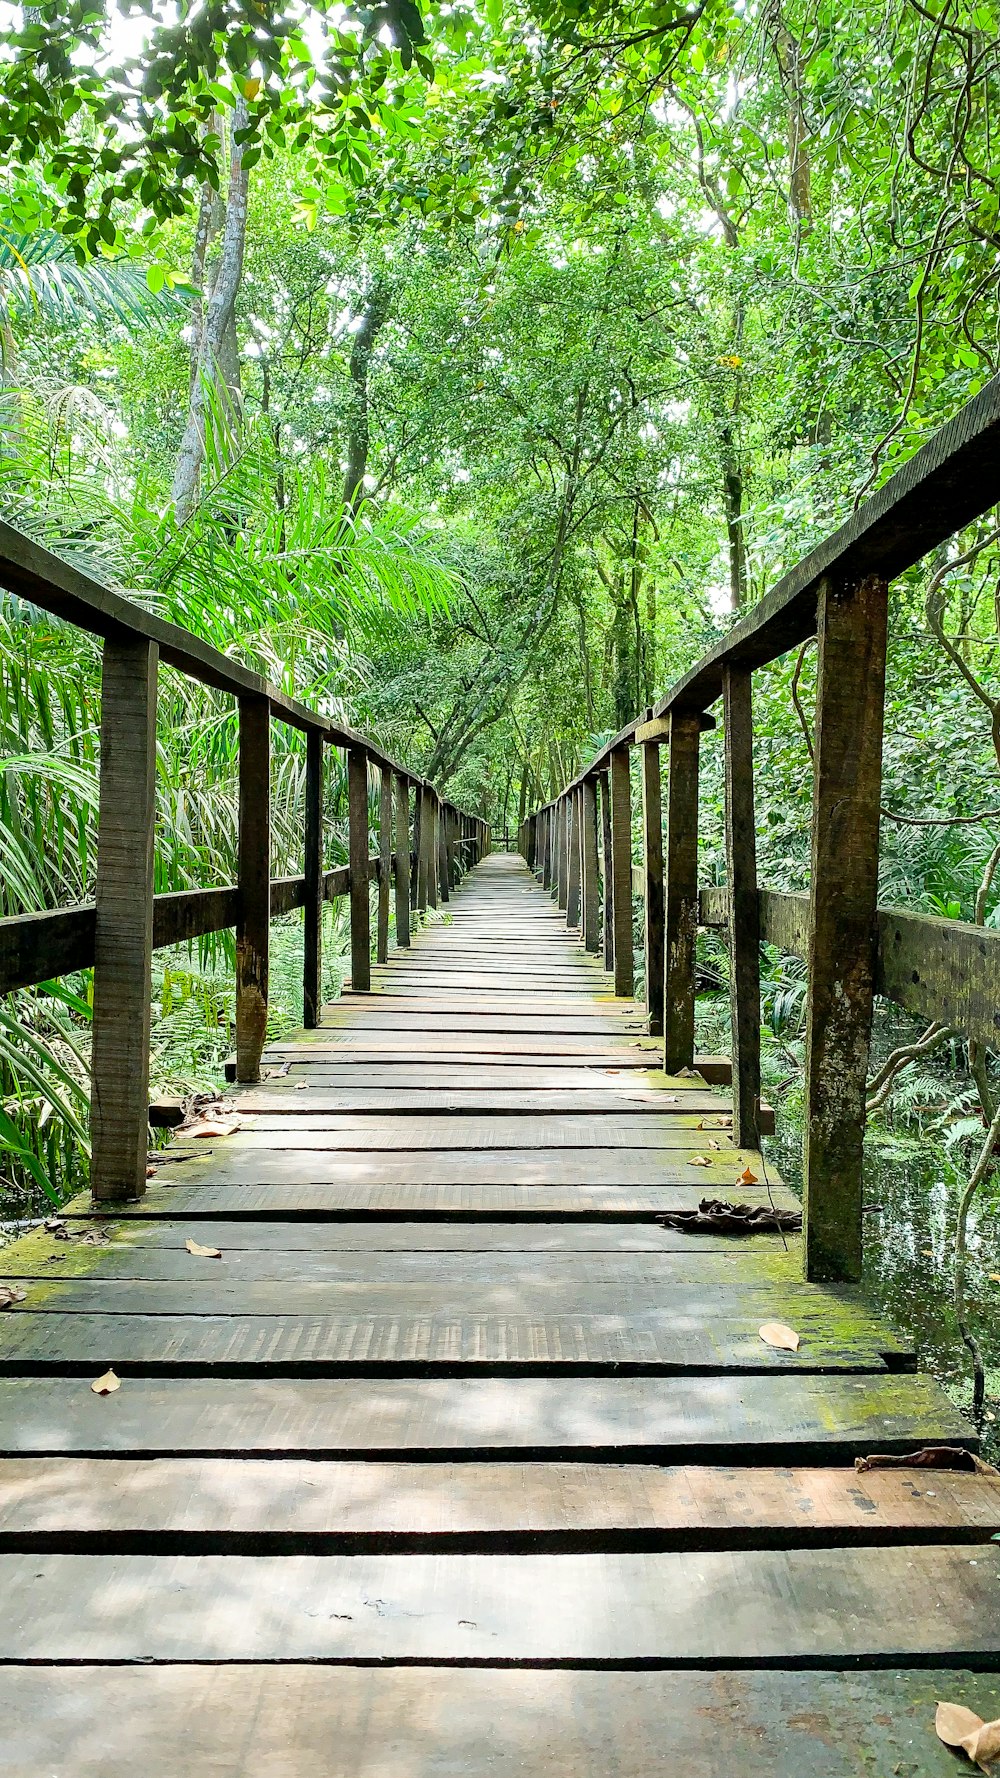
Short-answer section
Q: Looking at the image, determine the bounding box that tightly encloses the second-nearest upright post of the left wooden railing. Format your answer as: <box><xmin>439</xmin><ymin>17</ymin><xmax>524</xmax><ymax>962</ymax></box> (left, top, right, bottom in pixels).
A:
<box><xmin>237</xmin><ymin>697</ymin><xmax>270</xmax><ymax>1085</ymax></box>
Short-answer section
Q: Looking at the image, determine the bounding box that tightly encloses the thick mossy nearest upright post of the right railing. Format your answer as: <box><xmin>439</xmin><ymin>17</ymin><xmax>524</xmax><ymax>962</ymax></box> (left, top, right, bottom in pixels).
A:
<box><xmin>802</xmin><ymin>576</ymin><xmax>888</xmax><ymax>1280</ymax></box>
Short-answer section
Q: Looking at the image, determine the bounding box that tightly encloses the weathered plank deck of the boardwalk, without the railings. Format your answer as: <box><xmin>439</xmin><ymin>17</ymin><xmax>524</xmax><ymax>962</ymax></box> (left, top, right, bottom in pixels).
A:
<box><xmin>0</xmin><ymin>855</ymin><xmax>1000</xmax><ymax>1778</ymax></box>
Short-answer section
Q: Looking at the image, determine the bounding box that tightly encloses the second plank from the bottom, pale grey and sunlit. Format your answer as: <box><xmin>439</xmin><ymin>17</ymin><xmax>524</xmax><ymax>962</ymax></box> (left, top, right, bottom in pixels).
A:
<box><xmin>0</xmin><ymin>1543</ymin><xmax>1000</xmax><ymax>1668</ymax></box>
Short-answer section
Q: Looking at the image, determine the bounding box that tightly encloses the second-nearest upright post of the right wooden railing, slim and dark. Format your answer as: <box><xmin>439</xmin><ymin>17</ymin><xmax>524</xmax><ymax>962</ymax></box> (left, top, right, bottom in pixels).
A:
<box><xmin>722</xmin><ymin>667</ymin><xmax>760</xmax><ymax>1149</ymax></box>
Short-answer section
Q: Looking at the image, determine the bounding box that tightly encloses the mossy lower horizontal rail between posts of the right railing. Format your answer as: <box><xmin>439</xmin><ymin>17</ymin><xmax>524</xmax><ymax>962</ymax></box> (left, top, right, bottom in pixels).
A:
<box><xmin>699</xmin><ymin>887</ymin><xmax>1000</xmax><ymax>1047</ymax></box>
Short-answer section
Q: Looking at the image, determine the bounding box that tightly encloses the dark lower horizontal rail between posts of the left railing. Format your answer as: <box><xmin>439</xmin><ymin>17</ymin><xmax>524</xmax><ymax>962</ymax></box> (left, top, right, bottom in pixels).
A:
<box><xmin>0</xmin><ymin>855</ymin><xmax>389</xmax><ymax>994</ymax></box>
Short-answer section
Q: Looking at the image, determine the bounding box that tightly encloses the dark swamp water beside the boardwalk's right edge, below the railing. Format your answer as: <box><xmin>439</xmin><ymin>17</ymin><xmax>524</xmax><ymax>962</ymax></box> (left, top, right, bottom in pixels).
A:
<box><xmin>765</xmin><ymin>1113</ymin><xmax>1000</xmax><ymax>1462</ymax></box>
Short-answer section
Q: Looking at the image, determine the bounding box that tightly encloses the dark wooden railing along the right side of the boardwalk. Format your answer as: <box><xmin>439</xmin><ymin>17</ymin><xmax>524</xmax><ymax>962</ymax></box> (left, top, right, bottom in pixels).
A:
<box><xmin>518</xmin><ymin>379</ymin><xmax>1000</xmax><ymax>1280</ymax></box>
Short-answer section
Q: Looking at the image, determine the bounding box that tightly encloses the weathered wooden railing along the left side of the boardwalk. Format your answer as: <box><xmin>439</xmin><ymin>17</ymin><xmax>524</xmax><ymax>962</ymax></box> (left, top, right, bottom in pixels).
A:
<box><xmin>0</xmin><ymin>525</ymin><xmax>489</xmax><ymax>1200</ymax></box>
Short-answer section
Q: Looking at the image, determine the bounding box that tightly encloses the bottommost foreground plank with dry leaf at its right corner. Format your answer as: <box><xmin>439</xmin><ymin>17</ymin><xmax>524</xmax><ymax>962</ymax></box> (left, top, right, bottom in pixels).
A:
<box><xmin>0</xmin><ymin>1662</ymin><xmax>993</xmax><ymax>1778</ymax></box>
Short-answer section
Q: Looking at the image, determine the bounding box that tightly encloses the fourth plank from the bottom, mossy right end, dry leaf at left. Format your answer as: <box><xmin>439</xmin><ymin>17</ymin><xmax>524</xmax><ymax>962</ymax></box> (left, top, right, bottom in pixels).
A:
<box><xmin>0</xmin><ymin>1373</ymin><xmax>975</xmax><ymax>1457</ymax></box>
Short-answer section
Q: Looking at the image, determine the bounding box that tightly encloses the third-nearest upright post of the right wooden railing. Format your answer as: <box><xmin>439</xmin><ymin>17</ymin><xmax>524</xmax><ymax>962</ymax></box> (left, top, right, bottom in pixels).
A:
<box><xmin>664</xmin><ymin>709</ymin><xmax>701</xmax><ymax>1074</ymax></box>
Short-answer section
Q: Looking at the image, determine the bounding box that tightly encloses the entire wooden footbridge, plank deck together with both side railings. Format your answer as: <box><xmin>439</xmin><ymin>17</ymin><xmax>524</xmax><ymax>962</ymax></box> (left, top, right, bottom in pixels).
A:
<box><xmin>0</xmin><ymin>386</ymin><xmax>1000</xmax><ymax>1778</ymax></box>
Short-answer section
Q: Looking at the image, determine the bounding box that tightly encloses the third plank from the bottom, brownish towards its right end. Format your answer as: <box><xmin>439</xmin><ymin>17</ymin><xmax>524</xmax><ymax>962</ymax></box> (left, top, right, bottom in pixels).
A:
<box><xmin>0</xmin><ymin>1456</ymin><xmax>1000</xmax><ymax>1556</ymax></box>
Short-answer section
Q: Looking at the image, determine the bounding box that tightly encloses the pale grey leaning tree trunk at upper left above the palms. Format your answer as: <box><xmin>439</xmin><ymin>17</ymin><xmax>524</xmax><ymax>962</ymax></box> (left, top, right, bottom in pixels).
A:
<box><xmin>173</xmin><ymin>100</ymin><xmax>249</xmax><ymax>525</ymax></box>
